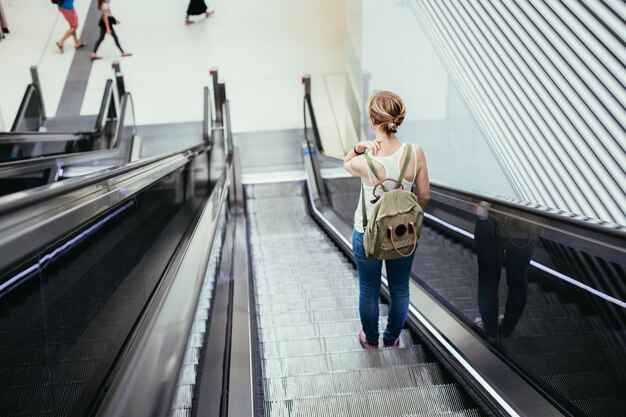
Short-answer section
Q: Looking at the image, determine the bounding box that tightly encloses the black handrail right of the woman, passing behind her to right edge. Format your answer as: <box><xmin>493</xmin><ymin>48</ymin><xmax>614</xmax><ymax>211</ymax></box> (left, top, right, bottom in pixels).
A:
<box><xmin>305</xmin><ymin>90</ymin><xmax>626</xmax><ymax>240</ymax></box>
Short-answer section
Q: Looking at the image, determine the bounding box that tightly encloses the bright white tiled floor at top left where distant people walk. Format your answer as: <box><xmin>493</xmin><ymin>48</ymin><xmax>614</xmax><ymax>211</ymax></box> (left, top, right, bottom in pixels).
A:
<box><xmin>0</xmin><ymin>0</ymin><xmax>345</xmax><ymax>134</ymax></box>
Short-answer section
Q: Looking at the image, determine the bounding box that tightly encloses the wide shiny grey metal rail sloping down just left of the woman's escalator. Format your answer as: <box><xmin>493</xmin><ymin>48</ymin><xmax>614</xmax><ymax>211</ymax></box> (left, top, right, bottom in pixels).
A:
<box><xmin>96</xmin><ymin>164</ymin><xmax>232</xmax><ymax>417</ymax></box>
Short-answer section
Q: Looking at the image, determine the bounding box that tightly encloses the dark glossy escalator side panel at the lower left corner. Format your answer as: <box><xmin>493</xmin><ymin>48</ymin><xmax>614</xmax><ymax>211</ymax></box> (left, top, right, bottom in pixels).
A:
<box><xmin>0</xmin><ymin>176</ymin><xmax>181</xmax><ymax>416</ymax></box>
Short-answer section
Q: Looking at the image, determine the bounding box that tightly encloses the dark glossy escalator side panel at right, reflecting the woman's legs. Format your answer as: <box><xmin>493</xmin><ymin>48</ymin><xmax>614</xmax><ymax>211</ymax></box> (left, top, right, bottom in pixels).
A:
<box><xmin>413</xmin><ymin>211</ymin><xmax>626</xmax><ymax>416</ymax></box>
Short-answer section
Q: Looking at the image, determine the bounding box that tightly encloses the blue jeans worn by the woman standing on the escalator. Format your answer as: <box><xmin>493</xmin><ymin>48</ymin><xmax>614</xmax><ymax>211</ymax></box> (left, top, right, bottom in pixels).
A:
<box><xmin>352</xmin><ymin>230</ymin><xmax>415</xmax><ymax>345</ymax></box>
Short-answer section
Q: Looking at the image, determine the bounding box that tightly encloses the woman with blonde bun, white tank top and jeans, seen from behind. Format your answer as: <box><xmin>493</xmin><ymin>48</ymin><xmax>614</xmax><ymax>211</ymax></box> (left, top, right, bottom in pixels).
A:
<box><xmin>344</xmin><ymin>91</ymin><xmax>430</xmax><ymax>349</ymax></box>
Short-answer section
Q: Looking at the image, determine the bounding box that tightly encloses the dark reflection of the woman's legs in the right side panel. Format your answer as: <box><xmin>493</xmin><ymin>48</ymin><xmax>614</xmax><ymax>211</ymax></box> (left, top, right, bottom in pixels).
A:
<box><xmin>474</xmin><ymin>220</ymin><xmax>535</xmax><ymax>337</ymax></box>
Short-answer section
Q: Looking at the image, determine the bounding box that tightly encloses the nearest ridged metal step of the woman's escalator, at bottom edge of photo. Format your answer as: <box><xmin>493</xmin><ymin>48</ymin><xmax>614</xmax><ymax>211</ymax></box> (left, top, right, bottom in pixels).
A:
<box><xmin>265</xmin><ymin>385</ymin><xmax>472</xmax><ymax>417</ymax></box>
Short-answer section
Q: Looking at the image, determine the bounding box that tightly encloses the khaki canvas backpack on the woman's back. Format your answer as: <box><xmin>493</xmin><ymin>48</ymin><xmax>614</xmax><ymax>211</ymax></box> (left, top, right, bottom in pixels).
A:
<box><xmin>361</xmin><ymin>144</ymin><xmax>424</xmax><ymax>259</ymax></box>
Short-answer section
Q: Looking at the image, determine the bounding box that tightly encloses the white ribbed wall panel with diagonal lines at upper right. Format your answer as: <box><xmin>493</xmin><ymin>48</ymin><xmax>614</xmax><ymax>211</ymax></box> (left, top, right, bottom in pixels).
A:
<box><xmin>411</xmin><ymin>0</ymin><xmax>626</xmax><ymax>225</ymax></box>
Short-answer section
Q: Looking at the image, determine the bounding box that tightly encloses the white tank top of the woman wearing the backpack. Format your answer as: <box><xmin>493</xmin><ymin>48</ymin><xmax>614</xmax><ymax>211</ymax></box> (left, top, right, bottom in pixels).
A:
<box><xmin>354</xmin><ymin>143</ymin><xmax>417</xmax><ymax>233</ymax></box>
